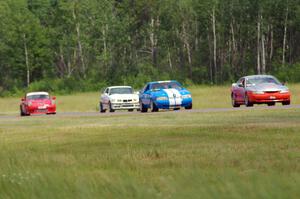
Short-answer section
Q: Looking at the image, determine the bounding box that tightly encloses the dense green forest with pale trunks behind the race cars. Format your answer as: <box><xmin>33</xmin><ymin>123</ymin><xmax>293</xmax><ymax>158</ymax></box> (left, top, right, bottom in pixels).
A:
<box><xmin>0</xmin><ymin>0</ymin><xmax>300</xmax><ymax>95</ymax></box>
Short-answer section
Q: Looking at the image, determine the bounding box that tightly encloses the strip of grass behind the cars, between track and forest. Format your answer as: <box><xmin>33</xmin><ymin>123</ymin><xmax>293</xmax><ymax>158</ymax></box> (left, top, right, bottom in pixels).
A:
<box><xmin>0</xmin><ymin>84</ymin><xmax>300</xmax><ymax>115</ymax></box>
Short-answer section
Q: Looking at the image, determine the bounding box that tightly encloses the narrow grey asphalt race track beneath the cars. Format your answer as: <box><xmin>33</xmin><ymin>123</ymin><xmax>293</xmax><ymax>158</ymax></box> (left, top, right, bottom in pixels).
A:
<box><xmin>0</xmin><ymin>105</ymin><xmax>300</xmax><ymax>120</ymax></box>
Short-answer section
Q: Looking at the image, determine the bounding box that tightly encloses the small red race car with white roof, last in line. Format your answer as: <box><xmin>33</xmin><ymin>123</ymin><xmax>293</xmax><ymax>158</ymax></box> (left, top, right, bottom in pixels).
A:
<box><xmin>20</xmin><ymin>92</ymin><xmax>56</xmax><ymax>116</ymax></box>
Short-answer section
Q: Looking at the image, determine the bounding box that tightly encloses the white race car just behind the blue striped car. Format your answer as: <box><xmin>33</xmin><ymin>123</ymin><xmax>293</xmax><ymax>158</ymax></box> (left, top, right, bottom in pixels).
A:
<box><xmin>99</xmin><ymin>86</ymin><xmax>140</xmax><ymax>113</ymax></box>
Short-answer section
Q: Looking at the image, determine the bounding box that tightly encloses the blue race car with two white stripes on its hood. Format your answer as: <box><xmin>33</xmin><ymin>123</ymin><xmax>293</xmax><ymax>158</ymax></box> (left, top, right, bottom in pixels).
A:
<box><xmin>139</xmin><ymin>80</ymin><xmax>193</xmax><ymax>112</ymax></box>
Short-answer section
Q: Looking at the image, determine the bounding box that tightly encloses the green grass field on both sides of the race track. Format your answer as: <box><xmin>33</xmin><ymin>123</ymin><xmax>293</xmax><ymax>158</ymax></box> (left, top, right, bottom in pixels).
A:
<box><xmin>0</xmin><ymin>85</ymin><xmax>300</xmax><ymax>199</ymax></box>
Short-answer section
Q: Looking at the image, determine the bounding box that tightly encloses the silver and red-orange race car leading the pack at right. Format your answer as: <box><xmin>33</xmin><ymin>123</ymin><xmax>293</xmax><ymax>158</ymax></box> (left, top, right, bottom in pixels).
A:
<box><xmin>231</xmin><ymin>75</ymin><xmax>291</xmax><ymax>107</ymax></box>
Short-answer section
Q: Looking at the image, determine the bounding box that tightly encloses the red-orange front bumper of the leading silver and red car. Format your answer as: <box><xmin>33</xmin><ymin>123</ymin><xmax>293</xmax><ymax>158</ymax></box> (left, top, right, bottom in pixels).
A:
<box><xmin>248</xmin><ymin>92</ymin><xmax>291</xmax><ymax>103</ymax></box>
